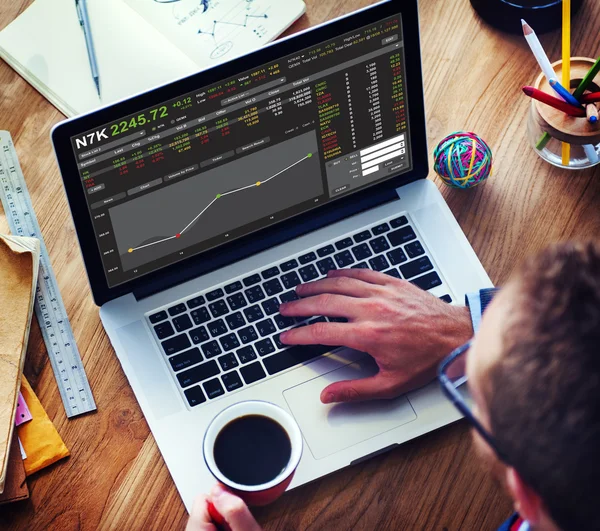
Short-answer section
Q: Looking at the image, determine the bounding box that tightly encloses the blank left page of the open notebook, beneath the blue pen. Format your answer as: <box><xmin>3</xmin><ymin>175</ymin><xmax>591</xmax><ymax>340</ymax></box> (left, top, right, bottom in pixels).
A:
<box><xmin>0</xmin><ymin>0</ymin><xmax>198</xmax><ymax>116</ymax></box>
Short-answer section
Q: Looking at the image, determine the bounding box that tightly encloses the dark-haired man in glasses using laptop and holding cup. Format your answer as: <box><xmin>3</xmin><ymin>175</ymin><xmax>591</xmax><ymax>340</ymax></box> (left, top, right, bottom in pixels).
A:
<box><xmin>188</xmin><ymin>244</ymin><xmax>600</xmax><ymax>531</ymax></box>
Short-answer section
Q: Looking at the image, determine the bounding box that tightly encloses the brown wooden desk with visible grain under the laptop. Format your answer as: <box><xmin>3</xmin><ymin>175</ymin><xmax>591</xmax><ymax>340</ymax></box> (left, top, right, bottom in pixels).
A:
<box><xmin>0</xmin><ymin>0</ymin><xmax>600</xmax><ymax>531</ymax></box>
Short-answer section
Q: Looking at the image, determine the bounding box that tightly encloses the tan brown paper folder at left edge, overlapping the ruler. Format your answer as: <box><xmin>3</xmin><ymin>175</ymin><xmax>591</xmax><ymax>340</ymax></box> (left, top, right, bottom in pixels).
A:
<box><xmin>0</xmin><ymin>236</ymin><xmax>40</xmax><ymax>494</ymax></box>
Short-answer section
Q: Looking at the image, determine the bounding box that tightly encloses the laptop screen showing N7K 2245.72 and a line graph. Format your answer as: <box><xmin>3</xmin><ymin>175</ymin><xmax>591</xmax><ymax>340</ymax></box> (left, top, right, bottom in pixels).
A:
<box><xmin>71</xmin><ymin>15</ymin><xmax>412</xmax><ymax>288</ymax></box>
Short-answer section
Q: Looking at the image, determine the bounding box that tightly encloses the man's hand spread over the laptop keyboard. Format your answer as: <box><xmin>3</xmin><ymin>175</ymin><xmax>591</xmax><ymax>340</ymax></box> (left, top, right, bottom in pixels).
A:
<box><xmin>280</xmin><ymin>269</ymin><xmax>473</xmax><ymax>404</ymax></box>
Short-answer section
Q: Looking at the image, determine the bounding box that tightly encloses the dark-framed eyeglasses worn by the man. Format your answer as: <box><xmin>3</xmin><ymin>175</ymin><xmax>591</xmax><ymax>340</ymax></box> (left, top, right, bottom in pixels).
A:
<box><xmin>438</xmin><ymin>341</ymin><xmax>508</xmax><ymax>463</ymax></box>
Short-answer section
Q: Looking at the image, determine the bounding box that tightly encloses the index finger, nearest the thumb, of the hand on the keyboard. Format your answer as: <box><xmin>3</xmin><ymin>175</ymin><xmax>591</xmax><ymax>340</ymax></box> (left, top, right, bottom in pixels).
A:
<box><xmin>281</xmin><ymin>323</ymin><xmax>362</xmax><ymax>350</ymax></box>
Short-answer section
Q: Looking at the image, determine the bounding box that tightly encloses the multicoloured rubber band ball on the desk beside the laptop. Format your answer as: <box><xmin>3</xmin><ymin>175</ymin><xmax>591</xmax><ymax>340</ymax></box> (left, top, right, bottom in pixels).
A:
<box><xmin>433</xmin><ymin>131</ymin><xmax>493</xmax><ymax>189</ymax></box>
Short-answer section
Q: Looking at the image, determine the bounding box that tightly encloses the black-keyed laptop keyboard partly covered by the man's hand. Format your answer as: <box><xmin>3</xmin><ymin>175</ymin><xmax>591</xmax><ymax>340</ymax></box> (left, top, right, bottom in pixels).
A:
<box><xmin>147</xmin><ymin>216</ymin><xmax>452</xmax><ymax>407</ymax></box>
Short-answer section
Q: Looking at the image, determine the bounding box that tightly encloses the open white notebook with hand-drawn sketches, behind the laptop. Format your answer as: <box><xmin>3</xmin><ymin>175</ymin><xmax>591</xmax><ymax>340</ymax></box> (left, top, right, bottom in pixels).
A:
<box><xmin>0</xmin><ymin>0</ymin><xmax>306</xmax><ymax>117</ymax></box>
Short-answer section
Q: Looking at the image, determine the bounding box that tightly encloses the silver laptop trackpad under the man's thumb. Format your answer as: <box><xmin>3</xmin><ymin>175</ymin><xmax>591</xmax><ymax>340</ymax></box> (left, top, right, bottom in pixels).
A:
<box><xmin>283</xmin><ymin>356</ymin><xmax>417</xmax><ymax>459</ymax></box>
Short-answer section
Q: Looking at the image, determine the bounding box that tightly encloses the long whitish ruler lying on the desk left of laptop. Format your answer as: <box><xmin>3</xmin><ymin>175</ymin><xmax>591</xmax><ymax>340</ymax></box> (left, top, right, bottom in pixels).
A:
<box><xmin>0</xmin><ymin>131</ymin><xmax>96</xmax><ymax>418</ymax></box>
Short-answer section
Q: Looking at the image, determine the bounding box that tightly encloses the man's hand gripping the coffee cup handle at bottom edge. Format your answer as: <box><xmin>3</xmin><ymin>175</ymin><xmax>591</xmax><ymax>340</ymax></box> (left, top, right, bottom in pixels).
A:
<box><xmin>185</xmin><ymin>485</ymin><xmax>261</xmax><ymax>531</ymax></box>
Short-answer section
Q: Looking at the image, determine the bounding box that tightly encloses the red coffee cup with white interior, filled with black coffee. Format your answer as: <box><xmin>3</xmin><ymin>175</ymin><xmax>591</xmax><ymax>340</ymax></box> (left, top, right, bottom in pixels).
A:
<box><xmin>203</xmin><ymin>400</ymin><xmax>303</xmax><ymax>505</ymax></box>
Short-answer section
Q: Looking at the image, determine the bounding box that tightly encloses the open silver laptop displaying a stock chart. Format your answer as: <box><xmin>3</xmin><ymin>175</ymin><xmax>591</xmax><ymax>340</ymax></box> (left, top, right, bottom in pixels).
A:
<box><xmin>52</xmin><ymin>0</ymin><xmax>491</xmax><ymax>510</ymax></box>
